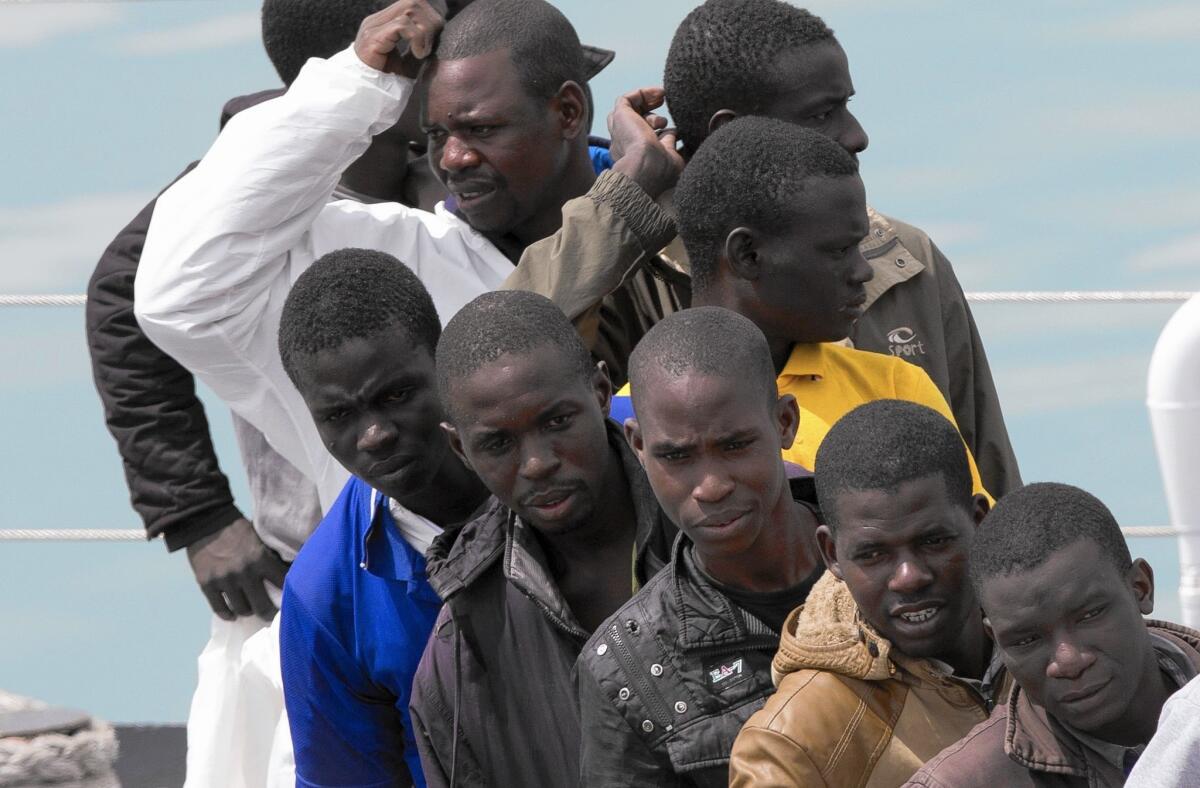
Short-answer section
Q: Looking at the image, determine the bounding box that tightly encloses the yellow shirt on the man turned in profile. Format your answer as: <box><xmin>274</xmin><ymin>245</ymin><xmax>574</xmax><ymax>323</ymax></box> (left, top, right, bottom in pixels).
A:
<box><xmin>776</xmin><ymin>343</ymin><xmax>991</xmax><ymax>499</ymax></box>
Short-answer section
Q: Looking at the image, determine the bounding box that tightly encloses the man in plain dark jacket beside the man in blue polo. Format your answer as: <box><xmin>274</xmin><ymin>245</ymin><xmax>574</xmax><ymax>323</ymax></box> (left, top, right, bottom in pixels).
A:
<box><xmin>412</xmin><ymin>290</ymin><xmax>674</xmax><ymax>788</ymax></box>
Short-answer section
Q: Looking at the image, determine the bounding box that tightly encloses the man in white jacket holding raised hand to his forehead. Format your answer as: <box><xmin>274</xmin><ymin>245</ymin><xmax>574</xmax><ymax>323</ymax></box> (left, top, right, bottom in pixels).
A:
<box><xmin>136</xmin><ymin>0</ymin><xmax>676</xmax><ymax>515</ymax></box>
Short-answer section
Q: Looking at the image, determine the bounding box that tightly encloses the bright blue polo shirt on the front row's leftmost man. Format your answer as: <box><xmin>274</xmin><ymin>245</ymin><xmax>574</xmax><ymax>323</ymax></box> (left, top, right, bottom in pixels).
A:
<box><xmin>280</xmin><ymin>477</ymin><xmax>442</xmax><ymax>788</ymax></box>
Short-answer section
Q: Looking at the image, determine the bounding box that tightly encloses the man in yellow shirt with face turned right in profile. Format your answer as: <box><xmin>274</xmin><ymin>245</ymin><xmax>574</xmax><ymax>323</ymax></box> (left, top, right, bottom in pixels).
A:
<box><xmin>643</xmin><ymin>116</ymin><xmax>985</xmax><ymax>493</ymax></box>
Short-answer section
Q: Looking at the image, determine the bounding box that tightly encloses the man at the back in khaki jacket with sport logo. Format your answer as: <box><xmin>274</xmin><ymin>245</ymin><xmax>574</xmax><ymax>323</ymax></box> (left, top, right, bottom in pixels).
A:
<box><xmin>662</xmin><ymin>0</ymin><xmax>1021</xmax><ymax>495</ymax></box>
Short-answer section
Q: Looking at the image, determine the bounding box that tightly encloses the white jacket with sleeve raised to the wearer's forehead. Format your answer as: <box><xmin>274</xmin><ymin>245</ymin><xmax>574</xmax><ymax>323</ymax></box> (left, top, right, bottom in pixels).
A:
<box><xmin>134</xmin><ymin>49</ymin><xmax>514</xmax><ymax>520</ymax></box>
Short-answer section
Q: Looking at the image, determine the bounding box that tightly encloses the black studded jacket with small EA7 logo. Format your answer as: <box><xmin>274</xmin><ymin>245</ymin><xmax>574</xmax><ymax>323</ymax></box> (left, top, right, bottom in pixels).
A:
<box><xmin>576</xmin><ymin>475</ymin><xmax>816</xmax><ymax>788</ymax></box>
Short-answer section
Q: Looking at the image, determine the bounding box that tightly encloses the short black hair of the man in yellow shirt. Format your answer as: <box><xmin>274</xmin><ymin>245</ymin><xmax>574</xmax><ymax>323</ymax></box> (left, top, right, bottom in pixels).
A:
<box><xmin>674</xmin><ymin>116</ymin><xmax>858</xmax><ymax>291</ymax></box>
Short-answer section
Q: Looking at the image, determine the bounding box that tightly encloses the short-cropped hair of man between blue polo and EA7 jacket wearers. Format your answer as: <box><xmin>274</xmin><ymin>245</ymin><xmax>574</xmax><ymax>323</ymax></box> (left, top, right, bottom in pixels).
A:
<box><xmin>437</xmin><ymin>290</ymin><xmax>595</xmax><ymax>421</ymax></box>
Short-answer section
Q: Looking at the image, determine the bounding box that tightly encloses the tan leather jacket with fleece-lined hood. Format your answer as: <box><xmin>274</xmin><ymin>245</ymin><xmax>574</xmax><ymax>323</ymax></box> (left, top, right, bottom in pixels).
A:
<box><xmin>730</xmin><ymin>575</ymin><xmax>1007</xmax><ymax>788</ymax></box>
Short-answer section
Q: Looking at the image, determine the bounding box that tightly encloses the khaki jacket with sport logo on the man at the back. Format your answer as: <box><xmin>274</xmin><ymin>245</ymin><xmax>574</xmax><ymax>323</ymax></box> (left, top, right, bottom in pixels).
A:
<box><xmin>503</xmin><ymin>182</ymin><xmax>1021</xmax><ymax>498</ymax></box>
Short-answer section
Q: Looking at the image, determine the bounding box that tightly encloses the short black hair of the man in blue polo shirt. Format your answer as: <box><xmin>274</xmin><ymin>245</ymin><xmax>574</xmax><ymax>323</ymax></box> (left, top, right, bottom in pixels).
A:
<box><xmin>280</xmin><ymin>248</ymin><xmax>442</xmax><ymax>384</ymax></box>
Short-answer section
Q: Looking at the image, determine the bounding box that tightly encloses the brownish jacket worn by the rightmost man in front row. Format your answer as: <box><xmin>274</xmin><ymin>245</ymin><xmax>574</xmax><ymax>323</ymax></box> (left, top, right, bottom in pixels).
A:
<box><xmin>905</xmin><ymin>620</ymin><xmax>1200</xmax><ymax>788</ymax></box>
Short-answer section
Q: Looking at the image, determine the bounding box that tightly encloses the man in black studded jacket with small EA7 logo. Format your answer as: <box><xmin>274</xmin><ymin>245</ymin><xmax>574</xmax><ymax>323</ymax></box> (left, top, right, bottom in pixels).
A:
<box><xmin>576</xmin><ymin>307</ymin><xmax>824</xmax><ymax>786</ymax></box>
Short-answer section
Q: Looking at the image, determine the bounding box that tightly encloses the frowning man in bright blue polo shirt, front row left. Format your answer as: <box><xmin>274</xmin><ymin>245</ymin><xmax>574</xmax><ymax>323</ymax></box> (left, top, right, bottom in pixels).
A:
<box><xmin>278</xmin><ymin>249</ymin><xmax>487</xmax><ymax>786</ymax></box>
